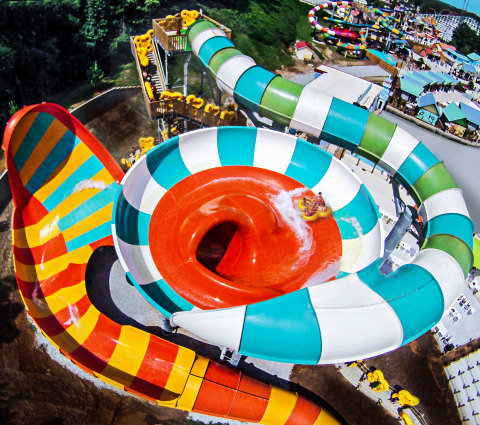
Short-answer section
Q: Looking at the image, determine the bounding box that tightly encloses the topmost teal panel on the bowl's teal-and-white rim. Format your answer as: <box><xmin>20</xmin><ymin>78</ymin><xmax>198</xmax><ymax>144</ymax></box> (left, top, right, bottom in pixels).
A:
<box><xmin>217</xmin><ymin>127</ymin><xmax>257</xmax><ymax>166</ymax></box>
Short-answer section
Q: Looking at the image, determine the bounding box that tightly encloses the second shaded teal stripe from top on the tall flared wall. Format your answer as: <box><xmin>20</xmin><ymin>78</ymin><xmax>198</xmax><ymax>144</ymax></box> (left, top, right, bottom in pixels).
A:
<box><xmin>25</xmin><ymin>130</ymin><xmax>80</xmax><ymax>193</ymax></box>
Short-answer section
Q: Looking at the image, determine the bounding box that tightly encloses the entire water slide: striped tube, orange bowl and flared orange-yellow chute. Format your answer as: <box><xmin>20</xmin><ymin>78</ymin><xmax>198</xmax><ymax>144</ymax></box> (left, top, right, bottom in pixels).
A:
<box><xmin>4</xmin><ymin>9</ymin><xmax>473</xmax><ymax>425</ymax></box>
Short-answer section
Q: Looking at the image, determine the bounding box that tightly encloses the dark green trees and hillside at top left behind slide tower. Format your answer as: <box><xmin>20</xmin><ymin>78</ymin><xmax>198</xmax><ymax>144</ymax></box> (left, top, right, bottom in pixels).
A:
<box><xmin>0</xmin><ymin>0</ymin><xmax>312</xmax><ymax>123</ymax></box>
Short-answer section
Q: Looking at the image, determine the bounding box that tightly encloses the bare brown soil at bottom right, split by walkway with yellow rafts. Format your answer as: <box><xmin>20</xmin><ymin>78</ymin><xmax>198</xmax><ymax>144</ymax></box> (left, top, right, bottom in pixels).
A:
<box><xmin>292</xmin><ymin>332</ymin><xmax>461</xmax><ymax>425</ymax></box>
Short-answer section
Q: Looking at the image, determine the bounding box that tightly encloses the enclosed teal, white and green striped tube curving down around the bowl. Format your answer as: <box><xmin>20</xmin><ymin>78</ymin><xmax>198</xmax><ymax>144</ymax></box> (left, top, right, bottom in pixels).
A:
<box><xmin>160</xmin><ymin>21</ymin><xmax>473</xmax><ymax>363</ymax></box>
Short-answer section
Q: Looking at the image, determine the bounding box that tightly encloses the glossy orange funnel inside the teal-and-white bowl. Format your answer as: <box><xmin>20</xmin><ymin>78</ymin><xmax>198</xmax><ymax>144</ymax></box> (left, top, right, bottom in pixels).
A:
<box><xmin>149</xmin><ymin>166</ymin><xmax>342</xmax><ymax>309</ymax></box>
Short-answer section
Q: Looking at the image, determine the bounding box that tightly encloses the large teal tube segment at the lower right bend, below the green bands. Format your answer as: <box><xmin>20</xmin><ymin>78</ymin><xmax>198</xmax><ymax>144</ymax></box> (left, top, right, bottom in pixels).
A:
<box><xmin>358</xmin><ymin>260</ymin><xmax>444</xmax><ymax>345</ymax></box>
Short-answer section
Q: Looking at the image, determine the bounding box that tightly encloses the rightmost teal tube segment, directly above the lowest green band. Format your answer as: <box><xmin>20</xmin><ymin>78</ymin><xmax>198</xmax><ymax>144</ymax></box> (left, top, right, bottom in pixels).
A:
<box><xmin>423</xmin><ymin>213</ymin><xmax>474</xmax><ymax>249</ymax></box>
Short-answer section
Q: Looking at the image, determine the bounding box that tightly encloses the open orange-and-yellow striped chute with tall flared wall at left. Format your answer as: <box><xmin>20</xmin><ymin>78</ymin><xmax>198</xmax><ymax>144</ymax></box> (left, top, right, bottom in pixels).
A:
<box><xmin>3</xmin><ymin>103</ymin><xmax>338</xmax><ymax>425</ymax></box>
